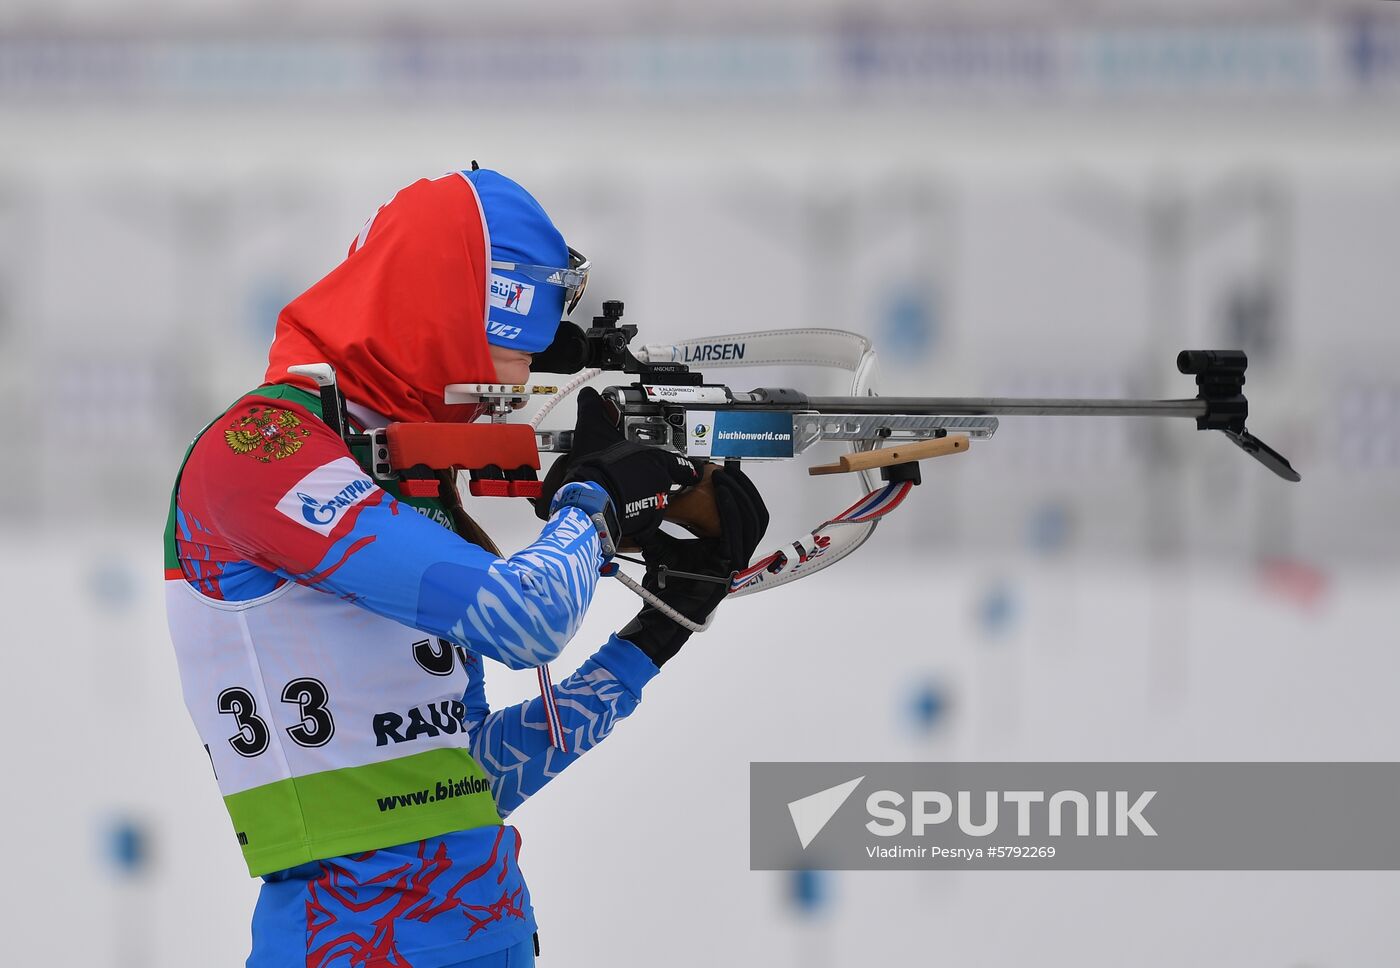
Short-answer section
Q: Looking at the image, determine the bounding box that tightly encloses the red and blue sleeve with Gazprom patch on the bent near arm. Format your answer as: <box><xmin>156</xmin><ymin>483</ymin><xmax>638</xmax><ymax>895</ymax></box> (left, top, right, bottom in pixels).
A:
<box><xmin>194</xmin><ymin>405</ymin><xmax>606</xmax><ymax>668</ymax></box>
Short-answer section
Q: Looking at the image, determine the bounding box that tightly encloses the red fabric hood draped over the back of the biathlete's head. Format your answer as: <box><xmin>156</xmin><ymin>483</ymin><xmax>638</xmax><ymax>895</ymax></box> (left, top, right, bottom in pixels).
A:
<box><xmin>265</xmin><ymin>172</ymin><xmax>496</xmax><ymax>422</ymax></box>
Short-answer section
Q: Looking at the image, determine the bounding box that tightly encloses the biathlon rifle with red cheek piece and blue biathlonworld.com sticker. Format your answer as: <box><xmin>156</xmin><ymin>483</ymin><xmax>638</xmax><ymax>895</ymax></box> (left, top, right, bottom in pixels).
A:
<box><xmin>293</xmin><ymin>301</ymin><xmax>1299</xmax><ymax>613</ymax></box>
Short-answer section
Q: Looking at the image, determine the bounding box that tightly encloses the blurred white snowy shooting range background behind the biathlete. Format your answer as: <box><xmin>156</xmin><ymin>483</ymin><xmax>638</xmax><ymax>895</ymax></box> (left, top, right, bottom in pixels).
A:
<box><xmin>0</xmin><ymin>0</ymin><xmax>1400</xmax><ymax>968</ymax></box>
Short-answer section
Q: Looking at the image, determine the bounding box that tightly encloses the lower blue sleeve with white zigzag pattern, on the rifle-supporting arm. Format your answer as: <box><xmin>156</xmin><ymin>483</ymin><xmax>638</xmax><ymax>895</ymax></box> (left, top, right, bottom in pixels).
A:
<box><xmin>463</xmin><ymin>635</ymin><xmax>657</xmax><ymax>820</ymax></box>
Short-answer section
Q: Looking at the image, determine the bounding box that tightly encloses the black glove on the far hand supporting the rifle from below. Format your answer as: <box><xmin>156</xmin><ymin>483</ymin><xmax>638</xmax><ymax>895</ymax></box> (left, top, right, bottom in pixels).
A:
<box><xmin>617</xmin><ymin>468</ymin><xmax>769</xmax><ymax>668</ymax></box>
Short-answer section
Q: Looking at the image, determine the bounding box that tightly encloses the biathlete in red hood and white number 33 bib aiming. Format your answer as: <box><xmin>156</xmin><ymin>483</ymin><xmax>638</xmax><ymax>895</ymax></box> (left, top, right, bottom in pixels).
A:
<box><xmin>165</xmin><ymin>167</ymin><xmax>769</xmax><ymax>968</ymax></box>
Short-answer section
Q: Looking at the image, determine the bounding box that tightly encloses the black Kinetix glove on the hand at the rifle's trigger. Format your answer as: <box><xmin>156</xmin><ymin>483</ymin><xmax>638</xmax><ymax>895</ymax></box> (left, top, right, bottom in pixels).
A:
<box><xmin>535</xmin><ymin>387</ymin><xmax>700</xmax><ymax>539</ymax></box>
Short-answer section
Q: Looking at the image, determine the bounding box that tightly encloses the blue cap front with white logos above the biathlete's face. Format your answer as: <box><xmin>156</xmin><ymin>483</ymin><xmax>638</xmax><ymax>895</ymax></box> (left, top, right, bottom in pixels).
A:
<box><xmin>462</xmin><ymin>168</ymin><xmax>568</xmax><ymax>353</ymax></box>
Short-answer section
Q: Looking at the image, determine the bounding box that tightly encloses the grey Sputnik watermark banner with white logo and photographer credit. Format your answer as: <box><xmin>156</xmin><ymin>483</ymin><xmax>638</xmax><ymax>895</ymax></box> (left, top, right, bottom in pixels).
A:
<box><xmin>750</xmin><ymin>763</ymin><xmax>1400</xmax><ymax>870</ymax></box>
